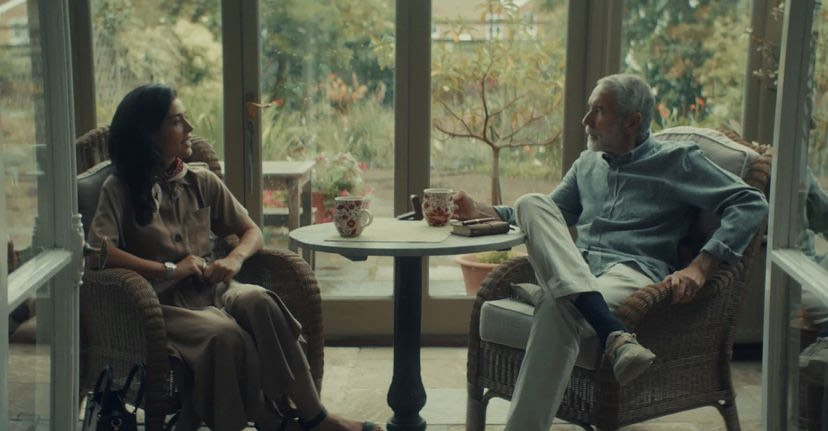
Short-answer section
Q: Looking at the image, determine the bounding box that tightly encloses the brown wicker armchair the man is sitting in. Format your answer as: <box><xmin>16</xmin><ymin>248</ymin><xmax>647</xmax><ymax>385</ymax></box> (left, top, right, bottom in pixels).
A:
<box><xmin>466</xmin><ymin>131</ymin><xmax>770</xmax><ymax>431</ymax></box>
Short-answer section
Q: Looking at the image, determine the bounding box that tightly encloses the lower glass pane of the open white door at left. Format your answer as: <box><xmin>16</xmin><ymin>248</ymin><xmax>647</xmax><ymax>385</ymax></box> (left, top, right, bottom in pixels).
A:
<box><xmin>8</xmin><ymin>287</ymin><xmax>51</xmax><ymax>431</ymax></box>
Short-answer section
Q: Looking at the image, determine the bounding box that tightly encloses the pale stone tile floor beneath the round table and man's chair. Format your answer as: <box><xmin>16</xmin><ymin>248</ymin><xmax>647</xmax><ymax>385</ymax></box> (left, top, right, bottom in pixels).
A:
<box><xmin>312</xmin><ymin>347</ymin><xmax>762</xmax><ymax>431</ymax></box>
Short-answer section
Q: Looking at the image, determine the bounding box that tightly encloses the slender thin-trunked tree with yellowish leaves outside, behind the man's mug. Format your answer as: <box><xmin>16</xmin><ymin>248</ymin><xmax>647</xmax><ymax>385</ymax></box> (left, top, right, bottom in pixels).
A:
<box><xmin>432</xmin><ymin>0</ymin><xmax>565</xmax><ymax>204</ymax></box>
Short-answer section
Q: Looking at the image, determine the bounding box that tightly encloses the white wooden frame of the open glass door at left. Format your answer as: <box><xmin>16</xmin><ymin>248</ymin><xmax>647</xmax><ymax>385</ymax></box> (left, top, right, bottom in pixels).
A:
<box><xmin>0</xmin><ymin>0</ymin><xmax>83</xmax><ymax>431</ymax></box>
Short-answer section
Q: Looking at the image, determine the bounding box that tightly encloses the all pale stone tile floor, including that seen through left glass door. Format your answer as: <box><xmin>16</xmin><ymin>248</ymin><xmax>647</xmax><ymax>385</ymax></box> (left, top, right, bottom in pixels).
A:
<box><xmin>4</xmin><ymin>345</ymin><xmax>762</xmax><ymax>431</ymax></box>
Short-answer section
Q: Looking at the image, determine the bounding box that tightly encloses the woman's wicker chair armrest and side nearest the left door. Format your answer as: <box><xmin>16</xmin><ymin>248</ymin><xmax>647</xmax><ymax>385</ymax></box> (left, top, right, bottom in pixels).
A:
<box><xmin>80</xmin><ymin>268</ymin><xmax>170</xmax><ymax>428</ymax></box>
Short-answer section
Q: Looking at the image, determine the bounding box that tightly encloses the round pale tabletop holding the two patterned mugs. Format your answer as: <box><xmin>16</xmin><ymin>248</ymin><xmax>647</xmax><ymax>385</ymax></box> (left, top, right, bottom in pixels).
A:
<box><xmin>289</xmin><ymin>218</ymin><xmax>526</xmax><ymax>257</ymax></box>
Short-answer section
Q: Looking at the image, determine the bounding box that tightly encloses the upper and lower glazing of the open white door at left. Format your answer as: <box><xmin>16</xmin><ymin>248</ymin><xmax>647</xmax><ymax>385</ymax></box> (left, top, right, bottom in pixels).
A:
<box><xmin>0</xmin><ymin>2</ymin><xmax>51</xmax><ymax>430</ymax></box>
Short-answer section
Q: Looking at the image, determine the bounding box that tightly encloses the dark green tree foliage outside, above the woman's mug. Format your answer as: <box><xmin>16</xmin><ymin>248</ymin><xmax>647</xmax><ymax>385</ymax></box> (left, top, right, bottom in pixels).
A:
<box><xmin>261</xmin><ymin>0</ymin><xmax>394</xmax><ymax>110</ymax></box>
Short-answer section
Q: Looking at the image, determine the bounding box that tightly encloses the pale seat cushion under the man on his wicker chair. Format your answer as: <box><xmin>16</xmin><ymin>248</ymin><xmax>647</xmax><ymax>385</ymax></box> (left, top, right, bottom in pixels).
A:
<box><xmin>480</xmin><ymin>298</ymin><xmax>603</xmax><ymax>370</ymax></box>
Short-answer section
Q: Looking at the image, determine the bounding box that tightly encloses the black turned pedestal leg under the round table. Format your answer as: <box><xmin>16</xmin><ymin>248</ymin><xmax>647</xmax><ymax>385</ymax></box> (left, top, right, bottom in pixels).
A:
<box><xmin>387</xmin><ymin>257</ymin><xmax>426</xmax><ymax>431</ymax></box>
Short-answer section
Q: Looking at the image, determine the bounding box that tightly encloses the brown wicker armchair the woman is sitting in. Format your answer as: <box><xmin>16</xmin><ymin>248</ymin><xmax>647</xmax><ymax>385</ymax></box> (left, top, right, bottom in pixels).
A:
<box><xmin>75</xmin><ymin>127</ymin><xmax>324</xmax><ymax>431</ymax></box>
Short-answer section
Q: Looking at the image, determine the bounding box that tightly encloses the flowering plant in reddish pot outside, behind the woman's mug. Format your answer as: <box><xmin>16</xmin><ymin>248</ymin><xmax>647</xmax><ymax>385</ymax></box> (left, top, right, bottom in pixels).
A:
<box><xmin>311</xmin><ymin>152</ymin><xmax>372</xmax><ymax>223</ymax></box>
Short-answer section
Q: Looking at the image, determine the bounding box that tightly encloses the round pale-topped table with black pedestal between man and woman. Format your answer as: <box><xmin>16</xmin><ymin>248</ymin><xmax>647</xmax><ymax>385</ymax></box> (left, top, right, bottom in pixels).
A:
<box><xmin>289</xmin><ymin>218</ymin><xmax>525</xmax><ymax>431</ymax></box>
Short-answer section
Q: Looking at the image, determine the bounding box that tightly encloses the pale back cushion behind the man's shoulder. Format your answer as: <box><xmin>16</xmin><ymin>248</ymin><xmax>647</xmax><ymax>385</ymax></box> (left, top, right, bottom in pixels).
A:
<box><xmin>653</xmin><ymin>126</ymin><xmax>759</xmax><ymax>178</ymax></box>
